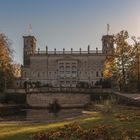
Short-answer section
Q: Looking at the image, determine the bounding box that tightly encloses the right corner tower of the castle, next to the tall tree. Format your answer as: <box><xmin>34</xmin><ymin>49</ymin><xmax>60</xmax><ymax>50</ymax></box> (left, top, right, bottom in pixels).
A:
<box><xmin>102</xmin><ymin>35</ymin><xmax>114</xmax><ymax>55</ymax></box>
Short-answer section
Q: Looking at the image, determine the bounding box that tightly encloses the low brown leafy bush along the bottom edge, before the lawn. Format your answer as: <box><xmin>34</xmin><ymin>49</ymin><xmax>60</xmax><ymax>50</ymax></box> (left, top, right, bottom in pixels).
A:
<box><xmin>34</xmin><ymin>123</ymin><xmax>140</xmax><ymax>140</ymax></box>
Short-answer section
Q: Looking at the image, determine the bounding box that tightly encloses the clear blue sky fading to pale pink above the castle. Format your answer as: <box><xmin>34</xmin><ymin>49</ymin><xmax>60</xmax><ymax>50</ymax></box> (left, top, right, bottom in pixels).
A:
<box><xmin>0</xmin><ymin>0</ymin><xmax>140</xmax><ymax>64</ymax></box>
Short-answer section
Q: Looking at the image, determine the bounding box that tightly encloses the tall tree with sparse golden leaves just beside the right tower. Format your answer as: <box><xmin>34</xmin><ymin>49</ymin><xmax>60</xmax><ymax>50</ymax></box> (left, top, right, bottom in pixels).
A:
<box><xmin>113</xmin><ymin>30</ymin><xmax>132</xmax><ymax>89</ymax></box>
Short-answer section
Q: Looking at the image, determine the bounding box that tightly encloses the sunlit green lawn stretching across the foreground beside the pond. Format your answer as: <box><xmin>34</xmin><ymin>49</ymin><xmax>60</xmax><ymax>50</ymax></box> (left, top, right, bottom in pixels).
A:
<box><xmin>0</xmin><ymin>106</ymin><xmax>140</xmax><ymax>140</ymax></box>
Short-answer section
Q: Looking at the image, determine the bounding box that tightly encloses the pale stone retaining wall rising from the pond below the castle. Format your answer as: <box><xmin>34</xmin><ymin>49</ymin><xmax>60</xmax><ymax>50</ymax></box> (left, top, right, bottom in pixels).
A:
<box><xmin>26</xmin><ymin>93</ymin><xmax>90</xmax><ymax>108</ymax></box>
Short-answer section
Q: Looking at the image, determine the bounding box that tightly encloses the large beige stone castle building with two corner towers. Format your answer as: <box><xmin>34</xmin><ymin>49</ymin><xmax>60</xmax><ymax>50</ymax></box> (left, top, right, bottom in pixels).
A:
<box><xmin>21</xmin><ymin>35</ymin><xmax>113</xmax><ymax>87</ymax></box>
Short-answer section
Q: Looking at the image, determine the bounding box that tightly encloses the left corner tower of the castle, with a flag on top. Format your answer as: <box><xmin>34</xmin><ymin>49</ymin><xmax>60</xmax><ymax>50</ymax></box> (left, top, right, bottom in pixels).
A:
<box><xmin>23</xmin><ymin>36</ymin><xmax>36</xmax><ymax>66</ymax></box>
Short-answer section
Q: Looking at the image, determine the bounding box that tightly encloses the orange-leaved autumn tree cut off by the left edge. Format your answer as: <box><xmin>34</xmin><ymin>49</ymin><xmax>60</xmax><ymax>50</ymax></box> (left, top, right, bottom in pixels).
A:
<box><xmin>0</xmin><ymin>33</ymin><xmax>13</xmax><ymax>91</ymax></box>
